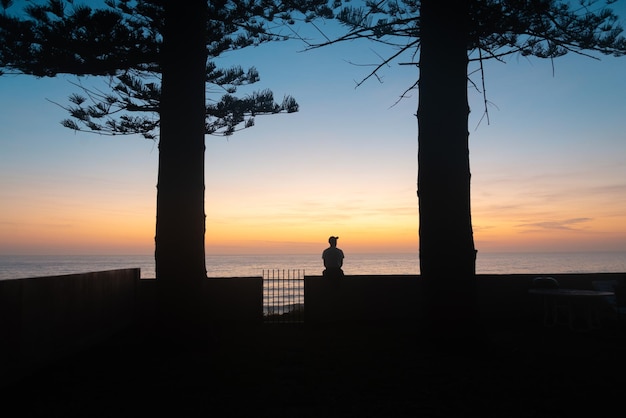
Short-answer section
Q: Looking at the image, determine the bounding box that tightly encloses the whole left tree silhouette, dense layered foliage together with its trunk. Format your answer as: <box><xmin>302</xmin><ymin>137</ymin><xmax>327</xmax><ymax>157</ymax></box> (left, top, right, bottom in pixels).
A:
<box><xmin>0</xmin><ymin>0</ymin><xmax>328</xmax><ymax>290</ymax></box>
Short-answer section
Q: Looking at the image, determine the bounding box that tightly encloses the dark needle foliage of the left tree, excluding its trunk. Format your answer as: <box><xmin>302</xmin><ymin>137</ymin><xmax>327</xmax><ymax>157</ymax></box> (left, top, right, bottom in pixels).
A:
<box><xmin>0</xmin><ymin>0</ymin><xmax>312</xmax><ymax>139</ymax></box>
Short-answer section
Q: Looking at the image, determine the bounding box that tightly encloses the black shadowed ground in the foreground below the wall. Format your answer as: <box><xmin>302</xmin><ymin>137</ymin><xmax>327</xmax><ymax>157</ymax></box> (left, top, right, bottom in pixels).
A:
<box><xmin>1</xmin><ymin>320</ymin><xmax>626</xmax><ymax>418</ymax></box>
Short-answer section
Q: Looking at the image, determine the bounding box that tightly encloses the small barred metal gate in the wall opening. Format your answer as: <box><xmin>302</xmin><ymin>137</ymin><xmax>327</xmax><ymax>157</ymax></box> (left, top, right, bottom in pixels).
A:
<box><xmin>263</xmin><ymin>270</ymin><xmax>304</xmax><ymax>324</ymax></box>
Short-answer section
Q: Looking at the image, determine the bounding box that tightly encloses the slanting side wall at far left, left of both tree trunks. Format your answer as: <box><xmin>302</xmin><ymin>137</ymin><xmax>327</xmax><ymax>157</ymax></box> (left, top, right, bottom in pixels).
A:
<box><xmin>0</xmin><ymin>269</ymin><xmax>140</xmax><ymax>387</ymax></box>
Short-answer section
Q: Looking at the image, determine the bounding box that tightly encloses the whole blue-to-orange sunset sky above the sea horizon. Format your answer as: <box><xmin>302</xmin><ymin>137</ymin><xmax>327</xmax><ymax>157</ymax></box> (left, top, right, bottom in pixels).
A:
<box><xmin>0</xmin><ymin>1</ymin><xmax>626</xmax><ymax>254</ymax></box>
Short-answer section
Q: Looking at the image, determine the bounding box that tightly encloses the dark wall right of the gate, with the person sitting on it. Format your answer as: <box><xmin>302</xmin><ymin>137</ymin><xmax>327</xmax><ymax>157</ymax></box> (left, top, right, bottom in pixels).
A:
<box><xmin>304</xmin><ymin>273</ymin><xmax>626</xmax><ymax>322</ymax></box>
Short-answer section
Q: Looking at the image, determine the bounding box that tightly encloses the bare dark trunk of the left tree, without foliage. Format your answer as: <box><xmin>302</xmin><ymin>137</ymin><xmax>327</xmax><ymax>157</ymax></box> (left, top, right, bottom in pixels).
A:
<box><xmin>155</xmin><ymin>0</ymin><xmax>206</xmax><ymax>334</ymax></box>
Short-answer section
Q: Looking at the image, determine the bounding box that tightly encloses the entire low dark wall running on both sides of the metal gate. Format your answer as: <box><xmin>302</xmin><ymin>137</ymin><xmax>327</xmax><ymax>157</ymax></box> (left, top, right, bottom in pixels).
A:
<box><xmin>0</xmin><ymin>269</ymin><xmax>626</xmax><ymax>387</ymax></box>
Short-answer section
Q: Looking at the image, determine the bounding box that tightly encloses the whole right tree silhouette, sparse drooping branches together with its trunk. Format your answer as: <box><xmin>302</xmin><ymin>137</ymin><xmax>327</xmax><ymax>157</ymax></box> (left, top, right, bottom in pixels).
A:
<box><xmin>298</xmin><ymin>0</ymin><xmax>626</xmax><ymax>332</ymax></box>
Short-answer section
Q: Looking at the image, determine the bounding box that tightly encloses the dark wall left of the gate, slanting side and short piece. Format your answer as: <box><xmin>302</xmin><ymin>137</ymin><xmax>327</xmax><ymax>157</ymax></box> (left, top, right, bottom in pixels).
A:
<box><xmin>0</xmin><ymin>269</ymin><xmax>263</xmax><ymax>388</ymax></box>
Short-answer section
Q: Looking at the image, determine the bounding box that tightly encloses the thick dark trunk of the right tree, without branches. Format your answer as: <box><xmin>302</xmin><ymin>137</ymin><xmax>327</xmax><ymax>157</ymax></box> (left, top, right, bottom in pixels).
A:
<box><xmin>417</xmin><ymin>0</ymin><xmax>476</xmax><ymax>334</ymax></box>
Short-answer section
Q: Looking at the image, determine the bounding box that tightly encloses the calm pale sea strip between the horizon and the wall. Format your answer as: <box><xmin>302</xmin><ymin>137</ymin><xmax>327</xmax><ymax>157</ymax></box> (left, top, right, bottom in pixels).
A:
<box><xmin>0</xmin><ymin>252</ymin><xmax>626</xmax><ymax>280</ymax></box>
